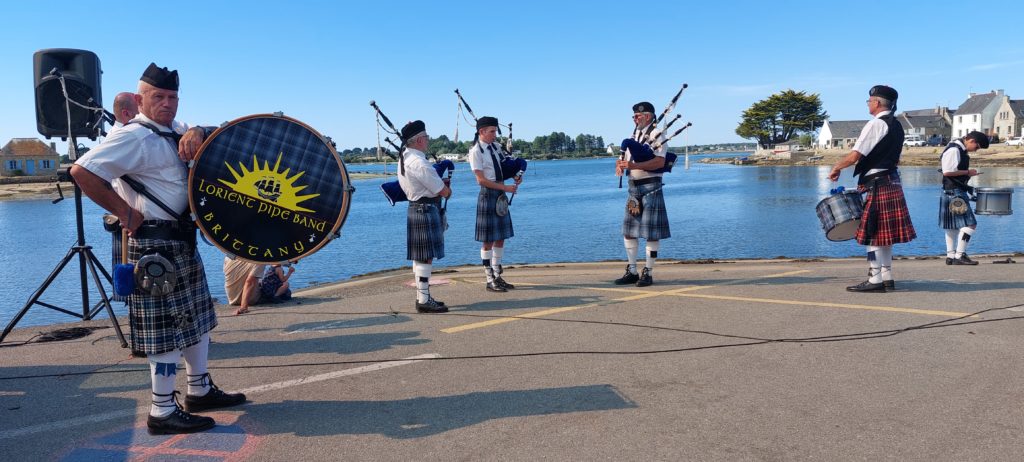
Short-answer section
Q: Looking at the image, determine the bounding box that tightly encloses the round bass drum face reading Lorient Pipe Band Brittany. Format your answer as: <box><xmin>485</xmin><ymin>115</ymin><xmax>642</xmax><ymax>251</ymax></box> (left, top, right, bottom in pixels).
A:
<box><xmin>188</xmin><ymin>114</ymin><xmax>354</xmax><ymax>263</ymax></box>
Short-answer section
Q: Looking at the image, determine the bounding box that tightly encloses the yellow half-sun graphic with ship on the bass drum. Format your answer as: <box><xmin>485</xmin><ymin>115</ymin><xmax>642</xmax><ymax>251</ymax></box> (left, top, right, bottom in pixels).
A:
<box><xmin>219</xmin><ymin>153</ymin><xmax>319</xmax><ymax>212</ymax></box>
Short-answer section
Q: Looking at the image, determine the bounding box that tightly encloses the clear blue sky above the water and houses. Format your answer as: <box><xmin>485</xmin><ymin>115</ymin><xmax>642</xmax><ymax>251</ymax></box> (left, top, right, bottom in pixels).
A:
<box><xmin>0</xmin><ymin>0</ymin><xmax>1024</xmax><ymax>148</ymax></box>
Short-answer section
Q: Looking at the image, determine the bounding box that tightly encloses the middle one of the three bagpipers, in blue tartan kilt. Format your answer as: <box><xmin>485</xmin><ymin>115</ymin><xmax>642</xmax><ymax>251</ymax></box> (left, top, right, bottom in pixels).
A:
<box><xmin>469</xmin><ymin>117</ymin><xmax>522</xmax><ymax>292</ymax></box>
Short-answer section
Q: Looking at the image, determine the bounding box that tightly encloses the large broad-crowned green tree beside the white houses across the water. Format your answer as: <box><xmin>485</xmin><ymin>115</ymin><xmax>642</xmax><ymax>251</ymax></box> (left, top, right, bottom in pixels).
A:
<box><xmin>736</xmin><ymin>90</ymin><xmax>828</xmax><ymax>148</ymax></box>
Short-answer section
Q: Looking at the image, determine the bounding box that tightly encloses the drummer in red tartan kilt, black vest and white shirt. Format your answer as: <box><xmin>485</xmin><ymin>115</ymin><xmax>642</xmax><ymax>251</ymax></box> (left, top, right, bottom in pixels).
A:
<box><xmin>828</xmin><ymin>85</ymin><xmax>918</xmax><ymax>292</ymax></box>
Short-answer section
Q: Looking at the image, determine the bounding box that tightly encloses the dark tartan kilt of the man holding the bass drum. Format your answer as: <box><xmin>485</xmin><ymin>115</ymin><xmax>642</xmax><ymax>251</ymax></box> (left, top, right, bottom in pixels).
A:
<box><xmin>128</xmin><ymin>238</ymin><xmax>217</xmax><ymax>354</ymax></box>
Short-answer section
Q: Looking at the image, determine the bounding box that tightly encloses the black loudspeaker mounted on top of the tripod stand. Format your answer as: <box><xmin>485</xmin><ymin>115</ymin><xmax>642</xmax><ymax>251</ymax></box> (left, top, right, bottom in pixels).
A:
<box><xmin>32</xmin><ymin>48</ymin><xmax>103</xmax><ymax>140</ymax></box>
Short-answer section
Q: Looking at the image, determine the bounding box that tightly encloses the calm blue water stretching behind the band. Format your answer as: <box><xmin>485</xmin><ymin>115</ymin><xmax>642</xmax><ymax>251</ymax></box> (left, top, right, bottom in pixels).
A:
<box><xmin>0</xmin><ymin>158</ymin><xmax>1024</xmax><ymax>327</ymax></box>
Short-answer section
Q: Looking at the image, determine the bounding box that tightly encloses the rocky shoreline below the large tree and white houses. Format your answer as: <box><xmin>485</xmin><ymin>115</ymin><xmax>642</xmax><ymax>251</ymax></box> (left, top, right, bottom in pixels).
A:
<box><xmin>700</xmin><ymin>144</ymin><xmax>1024</xmax><ymax>168</ymax></box>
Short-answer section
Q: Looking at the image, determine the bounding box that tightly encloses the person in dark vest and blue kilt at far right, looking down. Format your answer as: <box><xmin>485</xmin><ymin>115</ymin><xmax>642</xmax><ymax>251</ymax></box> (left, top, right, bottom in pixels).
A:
<box><xmin>939</xmin><ymin>131</ymin><xmax>988</xmax><ymax>265</ymax></box>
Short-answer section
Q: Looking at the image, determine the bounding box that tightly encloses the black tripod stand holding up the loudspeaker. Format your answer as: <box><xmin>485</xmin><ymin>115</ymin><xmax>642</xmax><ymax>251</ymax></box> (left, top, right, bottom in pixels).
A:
<box><xmin>0</xmin><ymin>142</ymin><xmax>128</xmax><ymax>348</ymax></box>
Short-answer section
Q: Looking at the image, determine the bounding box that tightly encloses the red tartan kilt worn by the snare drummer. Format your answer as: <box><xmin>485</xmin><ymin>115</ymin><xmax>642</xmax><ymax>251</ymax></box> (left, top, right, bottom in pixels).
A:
<box><xmin>857</xmin><ymin>175</ymin><xmax>918</xmax><ymax>246</ymax></box>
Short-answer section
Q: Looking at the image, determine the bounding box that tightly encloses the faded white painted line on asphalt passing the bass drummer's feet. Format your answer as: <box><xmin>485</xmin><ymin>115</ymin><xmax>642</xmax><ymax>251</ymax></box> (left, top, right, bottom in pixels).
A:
<box><xmin>0</xmin><ymin>353</ymin><xmax>441</xmax><ymax>439</ymax></box>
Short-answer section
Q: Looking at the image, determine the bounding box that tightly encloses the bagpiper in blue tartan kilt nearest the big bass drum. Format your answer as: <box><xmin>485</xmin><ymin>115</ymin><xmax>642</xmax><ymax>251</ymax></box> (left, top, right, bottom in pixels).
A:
<box><xmin>398</xmin><ymin>120</ymin><xmax>452</xmax><ymax>312</ymax></box>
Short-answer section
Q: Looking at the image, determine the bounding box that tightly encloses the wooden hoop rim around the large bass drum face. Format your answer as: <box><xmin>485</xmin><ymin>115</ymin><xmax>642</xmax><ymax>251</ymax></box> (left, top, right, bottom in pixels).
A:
<box><xmin>187</xmin><ymin>113</ymin><xmax>354</xmax><ymax>264</ymax></box>
